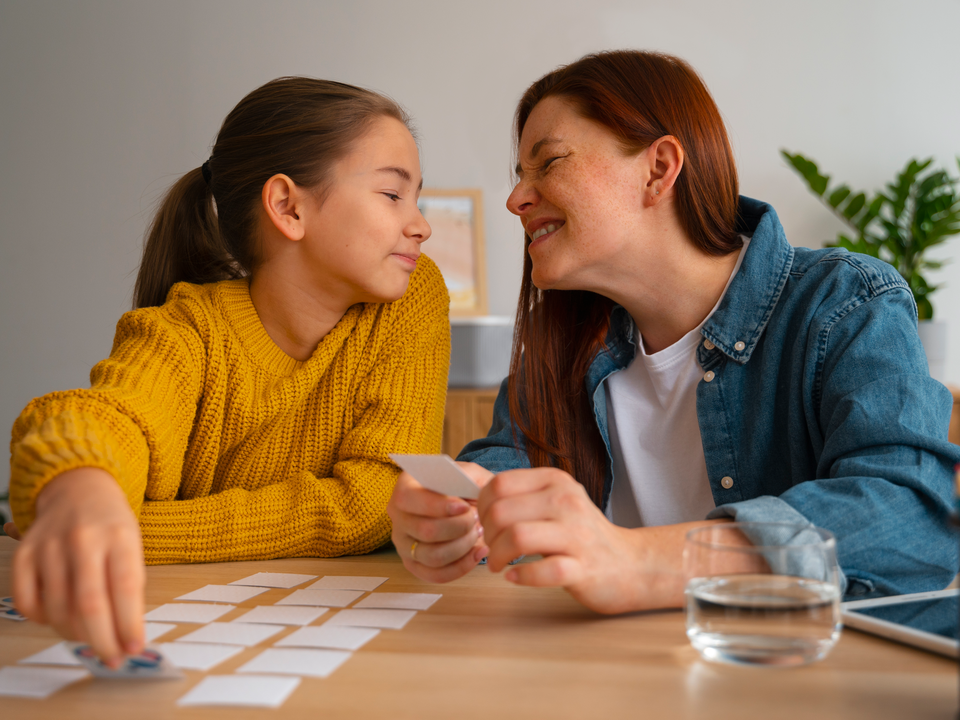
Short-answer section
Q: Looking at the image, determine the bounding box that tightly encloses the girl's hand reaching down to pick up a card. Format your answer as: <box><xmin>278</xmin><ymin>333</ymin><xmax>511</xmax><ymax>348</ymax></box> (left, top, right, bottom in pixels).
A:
<box><xmin>13</xmin><ymin>468</ymin><xmax>146</xmax><ymax>666</ymax></box>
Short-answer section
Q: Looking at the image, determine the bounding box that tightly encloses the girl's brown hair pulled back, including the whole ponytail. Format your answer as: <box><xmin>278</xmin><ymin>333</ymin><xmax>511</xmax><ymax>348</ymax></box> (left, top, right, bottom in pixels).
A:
<box><xmin>134</xmin><ymin>77</ymin><xmax>412</xmax><ymax>308</ymax></box>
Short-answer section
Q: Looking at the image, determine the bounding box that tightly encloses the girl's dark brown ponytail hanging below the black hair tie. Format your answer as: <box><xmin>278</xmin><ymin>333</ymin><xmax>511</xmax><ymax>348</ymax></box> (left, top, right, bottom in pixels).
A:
<box><xmin>133</xmin><ymin>168</ymin><xmax>242</xmax><ymax>309</ymax></box>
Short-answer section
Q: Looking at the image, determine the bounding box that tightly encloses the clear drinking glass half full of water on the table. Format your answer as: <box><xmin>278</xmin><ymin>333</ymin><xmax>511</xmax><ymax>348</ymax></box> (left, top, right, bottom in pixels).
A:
<box><xmin>683</xmin><ymin>523</ymin><xmax>841</xmax><ymax>666</ymax></box>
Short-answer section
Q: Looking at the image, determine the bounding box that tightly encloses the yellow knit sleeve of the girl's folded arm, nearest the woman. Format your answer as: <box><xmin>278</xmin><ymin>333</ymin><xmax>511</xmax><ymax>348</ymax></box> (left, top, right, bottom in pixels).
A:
<box><xmin>133</xmin><ymin>264</ymin><xmax>450</xmax><ymax>564</ymax></box>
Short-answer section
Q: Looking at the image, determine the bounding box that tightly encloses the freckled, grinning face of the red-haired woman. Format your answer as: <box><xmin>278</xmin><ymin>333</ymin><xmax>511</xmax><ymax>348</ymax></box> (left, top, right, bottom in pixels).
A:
<box><xmin>507</xmin><ymin>97</ymin><xmax>649</xmax><ymax>292</ymax></box>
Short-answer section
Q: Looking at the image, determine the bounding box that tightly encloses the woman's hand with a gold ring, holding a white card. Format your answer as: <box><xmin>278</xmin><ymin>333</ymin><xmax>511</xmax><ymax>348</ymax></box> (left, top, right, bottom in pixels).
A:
<box><xmin>387</xmin><ymin>463</ymin><xmax>493</xmax><ymax>583</ymax></box>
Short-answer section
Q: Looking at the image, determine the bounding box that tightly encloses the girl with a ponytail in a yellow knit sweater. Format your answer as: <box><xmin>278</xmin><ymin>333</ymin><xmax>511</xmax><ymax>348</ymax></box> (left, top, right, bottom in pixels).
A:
<box><xmin>10</xmin><ymin>78</ymin><xmax>449</xmax><ymax>664</ymax></box>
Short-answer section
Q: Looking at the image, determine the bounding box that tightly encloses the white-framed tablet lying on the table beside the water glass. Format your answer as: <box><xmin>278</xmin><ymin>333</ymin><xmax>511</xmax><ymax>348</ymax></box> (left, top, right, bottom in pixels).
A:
<box><xmin>840</xmin><ymin>588</ymin><xmax>960</xmax><ymax>658</ymax></box>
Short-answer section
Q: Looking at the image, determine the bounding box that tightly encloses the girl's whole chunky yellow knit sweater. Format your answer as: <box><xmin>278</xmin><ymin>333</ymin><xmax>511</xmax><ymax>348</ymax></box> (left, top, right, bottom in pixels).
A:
<box><xmin>10</xmin><ymin>256</ymin><xmax>450</xmax><ymax>563</ymax></box>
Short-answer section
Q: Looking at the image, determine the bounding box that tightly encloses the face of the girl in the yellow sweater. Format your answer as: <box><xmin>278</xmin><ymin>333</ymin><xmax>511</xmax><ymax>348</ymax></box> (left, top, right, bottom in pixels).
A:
<box><xmin>303</xmin><ymin>117</ymin><xmax>430</xmax><ymax>304</ymax></box>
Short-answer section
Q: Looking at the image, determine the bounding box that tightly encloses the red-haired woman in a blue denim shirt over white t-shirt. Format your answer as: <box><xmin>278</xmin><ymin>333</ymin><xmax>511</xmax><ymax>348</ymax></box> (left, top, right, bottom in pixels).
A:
<box><xmin>389</xmin><ymin>52</ymin><xmax>960</xmax><ymax>612</ymax></box>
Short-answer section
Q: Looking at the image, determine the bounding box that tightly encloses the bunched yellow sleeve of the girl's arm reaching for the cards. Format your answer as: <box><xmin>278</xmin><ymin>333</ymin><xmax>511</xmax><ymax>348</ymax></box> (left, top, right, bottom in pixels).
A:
<box><xmin>10</xmin><ymin>300</ymin><xmax>202</xmax><ymax>531</ymax></box>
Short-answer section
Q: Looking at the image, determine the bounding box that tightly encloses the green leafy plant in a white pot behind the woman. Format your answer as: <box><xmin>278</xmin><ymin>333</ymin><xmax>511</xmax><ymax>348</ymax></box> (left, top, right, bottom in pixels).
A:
<box><xmin>780</xmin><ymin>150</ymin><xmax>960</xmax><ymax>380</ymax></box>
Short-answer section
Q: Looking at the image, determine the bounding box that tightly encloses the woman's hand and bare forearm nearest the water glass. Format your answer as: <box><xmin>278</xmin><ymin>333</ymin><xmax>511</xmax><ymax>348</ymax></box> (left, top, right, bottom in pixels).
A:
<box><xmin>478</xmin><ymin>468</ymin><xmax>746</xmax><ymax>613</ymax></box>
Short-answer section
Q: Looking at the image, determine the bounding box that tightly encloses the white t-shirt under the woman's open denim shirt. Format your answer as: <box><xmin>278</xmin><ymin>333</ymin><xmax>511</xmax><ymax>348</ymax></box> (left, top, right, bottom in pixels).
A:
<box><xmin>606</xmin><ymin>237</ymin><xmax>749</xmax><ymax>528</ymax></box>
